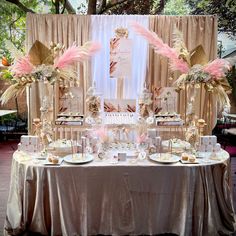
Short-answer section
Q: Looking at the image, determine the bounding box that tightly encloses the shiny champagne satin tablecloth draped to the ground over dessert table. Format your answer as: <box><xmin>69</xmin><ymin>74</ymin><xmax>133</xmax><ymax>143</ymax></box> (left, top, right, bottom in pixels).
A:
<box><xmin>4</xmin><ymin>151</ymin><xmax>235</xmax><ymax>236</ymax></box>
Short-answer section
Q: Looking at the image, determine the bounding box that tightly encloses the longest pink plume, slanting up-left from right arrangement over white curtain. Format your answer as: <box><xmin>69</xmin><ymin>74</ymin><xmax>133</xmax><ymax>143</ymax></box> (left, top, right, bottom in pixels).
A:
<box><xmin>131</xmin><ymin>22</ymin><xmax>189</xmax><ymax>73</ymax></box>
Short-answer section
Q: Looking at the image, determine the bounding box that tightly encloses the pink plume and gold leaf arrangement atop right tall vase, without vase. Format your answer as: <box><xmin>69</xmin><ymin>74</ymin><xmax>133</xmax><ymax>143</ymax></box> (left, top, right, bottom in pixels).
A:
<box><xmin>132</xmin><ymin>22</ymin><xmax>231</xmax><ymax>108</ymax></box>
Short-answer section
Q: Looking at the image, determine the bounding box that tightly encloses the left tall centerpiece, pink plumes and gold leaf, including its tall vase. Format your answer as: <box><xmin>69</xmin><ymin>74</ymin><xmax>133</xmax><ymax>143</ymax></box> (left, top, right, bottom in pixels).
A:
<box><xmin>0</xmin><ymin>40</ymin><xmax>100</xmax><ymax>142</ymax></box>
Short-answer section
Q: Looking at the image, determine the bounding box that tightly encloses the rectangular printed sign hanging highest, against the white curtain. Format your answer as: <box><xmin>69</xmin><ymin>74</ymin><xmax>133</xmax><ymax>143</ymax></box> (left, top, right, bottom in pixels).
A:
<box><xmin>110</xmin><ymin>38</ymin><xmax>132</xmax><ymax>78</ymax></box>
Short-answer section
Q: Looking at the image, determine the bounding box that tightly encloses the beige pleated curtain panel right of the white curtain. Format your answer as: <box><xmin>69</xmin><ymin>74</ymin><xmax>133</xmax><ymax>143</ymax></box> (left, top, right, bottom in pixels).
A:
<box><xmin>147</xmin><ymin>16</ymin><xmax>217</xmax><ymax>133</ymax></box>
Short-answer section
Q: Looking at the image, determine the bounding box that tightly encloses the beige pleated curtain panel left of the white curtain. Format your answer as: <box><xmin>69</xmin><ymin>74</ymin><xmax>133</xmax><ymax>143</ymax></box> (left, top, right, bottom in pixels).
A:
<box><xmin>26</xmin><ymin>13</ymin><xmax>91</xmax><ymax>131</ymax></box>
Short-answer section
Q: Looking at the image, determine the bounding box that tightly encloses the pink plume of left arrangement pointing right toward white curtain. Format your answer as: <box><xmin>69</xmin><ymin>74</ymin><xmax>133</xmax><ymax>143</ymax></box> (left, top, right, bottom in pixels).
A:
<box><xmin>54</xmin><ymin>42</ymin><xmax>101</xmax><ymax>69</ymax></box>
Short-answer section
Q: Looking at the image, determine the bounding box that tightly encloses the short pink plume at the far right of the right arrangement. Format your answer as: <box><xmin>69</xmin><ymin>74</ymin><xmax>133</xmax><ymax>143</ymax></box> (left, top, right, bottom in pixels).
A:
<box><xmin>203</xmin><ymin>58</ymin><xmax>230</xmax><ymax>78</ymax></box>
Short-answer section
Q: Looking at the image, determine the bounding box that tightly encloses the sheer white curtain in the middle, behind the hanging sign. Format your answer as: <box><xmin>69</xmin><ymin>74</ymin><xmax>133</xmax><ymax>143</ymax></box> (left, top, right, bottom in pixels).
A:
<box><xmin>91</xmin><ymin>15</ymin><xmax>148</xmax><ymax>98</ymax></box>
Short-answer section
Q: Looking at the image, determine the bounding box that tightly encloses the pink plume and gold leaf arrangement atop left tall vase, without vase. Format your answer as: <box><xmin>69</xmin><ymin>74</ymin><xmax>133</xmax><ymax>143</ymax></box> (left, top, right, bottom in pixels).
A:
<box><xmin>0</xmin><ymin>40</ymin><xmax>100</xmax><ymax>104</ymax></box>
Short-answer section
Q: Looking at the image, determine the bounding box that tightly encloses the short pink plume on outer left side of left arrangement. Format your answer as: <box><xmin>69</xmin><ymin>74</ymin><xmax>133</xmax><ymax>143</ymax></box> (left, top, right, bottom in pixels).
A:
<box><xmin>11</xmin><ymin>55</ymin><xmax>34</xmax><ymax>76</ymax></box>
